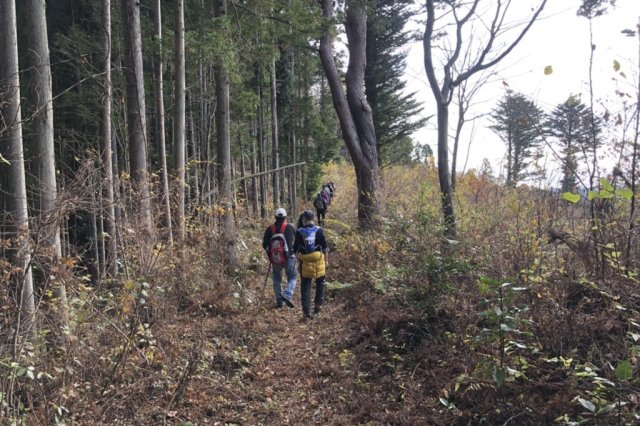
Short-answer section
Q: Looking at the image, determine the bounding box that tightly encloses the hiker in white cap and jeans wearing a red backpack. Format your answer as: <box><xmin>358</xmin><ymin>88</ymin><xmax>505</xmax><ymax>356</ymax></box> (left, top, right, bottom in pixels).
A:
<box><xmin>262</xmin><ymin>208</ymin><xmax>298</xmax><ymax>308</ymax></box>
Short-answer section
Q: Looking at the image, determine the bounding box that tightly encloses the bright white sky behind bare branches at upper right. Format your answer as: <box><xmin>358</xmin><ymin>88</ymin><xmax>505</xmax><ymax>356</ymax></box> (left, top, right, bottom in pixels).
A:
<box><xmin>406</xmin><ymin>0</ymin><xmax>640</xmax><ymax>180</ymax></box>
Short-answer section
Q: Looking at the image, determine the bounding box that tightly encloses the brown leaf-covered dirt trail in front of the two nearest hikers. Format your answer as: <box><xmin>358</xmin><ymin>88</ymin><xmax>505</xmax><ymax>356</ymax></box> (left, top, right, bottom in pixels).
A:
<box><xmin>177</xmin><ymin>288</ymin><xmax>364</xmax><ymax>425</ymax></box>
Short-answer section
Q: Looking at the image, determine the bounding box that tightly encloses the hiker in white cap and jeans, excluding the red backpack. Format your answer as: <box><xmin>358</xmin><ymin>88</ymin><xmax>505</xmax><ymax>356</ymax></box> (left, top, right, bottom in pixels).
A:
<box><xmin>262</xmin><ymin>208</ymin><xmax>298</xmax><ymax>308</ymax></box>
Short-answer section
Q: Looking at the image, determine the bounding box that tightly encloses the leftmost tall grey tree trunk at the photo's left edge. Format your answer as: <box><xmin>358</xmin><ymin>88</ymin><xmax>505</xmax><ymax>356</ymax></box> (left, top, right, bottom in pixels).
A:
<box><xmin>0</xmin><ymin>0</ymin><xmax>35</xmax><ymax>336</ymax></box>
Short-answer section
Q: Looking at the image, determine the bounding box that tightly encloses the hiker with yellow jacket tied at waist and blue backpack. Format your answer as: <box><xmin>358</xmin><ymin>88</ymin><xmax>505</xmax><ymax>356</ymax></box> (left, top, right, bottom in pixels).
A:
<box><xmin>293</xmin><ymin>210</ymin><xmax>329</xmax><ymax>319</ymax></box>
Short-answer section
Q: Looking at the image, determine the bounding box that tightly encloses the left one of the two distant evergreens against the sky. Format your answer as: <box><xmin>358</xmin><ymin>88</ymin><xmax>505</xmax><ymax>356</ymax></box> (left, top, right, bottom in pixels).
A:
<box><xmin>491</xmin><ymin>92</ymin><xmax>543</xmax><ymax>186</ymax></box>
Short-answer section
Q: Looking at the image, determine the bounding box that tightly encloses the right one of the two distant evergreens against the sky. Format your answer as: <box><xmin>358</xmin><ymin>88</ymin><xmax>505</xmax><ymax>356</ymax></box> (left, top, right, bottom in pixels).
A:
<box><xmin>545</xmin><ymin>95</ymin><xmax>601</xmax><ymax>191</ymax></box>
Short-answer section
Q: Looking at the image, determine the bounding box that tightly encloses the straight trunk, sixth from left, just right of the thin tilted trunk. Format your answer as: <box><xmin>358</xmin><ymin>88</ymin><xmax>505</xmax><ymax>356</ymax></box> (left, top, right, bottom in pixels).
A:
<box><xmin>173</xmin><ymin>0</ymin><xmax>186</xmax><ymax>242</ymax></box>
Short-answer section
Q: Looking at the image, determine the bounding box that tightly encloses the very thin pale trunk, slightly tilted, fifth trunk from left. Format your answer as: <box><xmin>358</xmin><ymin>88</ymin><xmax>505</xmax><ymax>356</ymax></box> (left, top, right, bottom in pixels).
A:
<box><xmin>153</xmin><ymin>0</ymin><xmax>173</xmax><ymax>244</ymax></box>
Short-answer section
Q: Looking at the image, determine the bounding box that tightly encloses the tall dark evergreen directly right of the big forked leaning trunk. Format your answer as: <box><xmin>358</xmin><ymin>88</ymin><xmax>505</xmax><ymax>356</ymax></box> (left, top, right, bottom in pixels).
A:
<box><xmin>365</xmin><ymin>0</ymin><xmax>426</xmax><ymax>165</ymax></box>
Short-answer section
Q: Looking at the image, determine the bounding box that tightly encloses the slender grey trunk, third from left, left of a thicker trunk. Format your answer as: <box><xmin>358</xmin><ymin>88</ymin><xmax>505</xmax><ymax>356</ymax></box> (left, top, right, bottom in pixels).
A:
<box><xmin>101</xmin><ymin>0</ymin><xmax>118</xmax><ymax>276</ymax></box>
